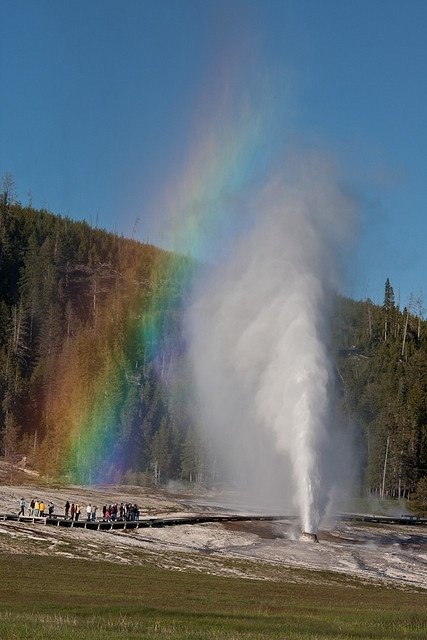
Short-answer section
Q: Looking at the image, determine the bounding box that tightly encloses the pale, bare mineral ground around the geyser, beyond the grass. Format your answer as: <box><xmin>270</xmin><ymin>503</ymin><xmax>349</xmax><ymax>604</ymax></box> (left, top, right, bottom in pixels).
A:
<box><xmin>0</xmin><ymin>476</ymin><xmax>427</xmax><ymax>588</ymax></box>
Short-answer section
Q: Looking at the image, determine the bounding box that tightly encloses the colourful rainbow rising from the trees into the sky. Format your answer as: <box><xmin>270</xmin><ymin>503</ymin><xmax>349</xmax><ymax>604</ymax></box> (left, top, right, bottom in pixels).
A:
<box><xmin>45</xmin><ymin>58</ymin><xmax>280</xmax><ymax>484</ymax></box>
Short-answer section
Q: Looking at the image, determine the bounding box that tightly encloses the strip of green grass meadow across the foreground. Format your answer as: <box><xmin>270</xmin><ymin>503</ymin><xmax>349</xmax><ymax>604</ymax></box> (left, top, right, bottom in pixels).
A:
<box><xmin>0</xmin><ymin>554</ymin><xmax>427</xmax><ymax>640</ymax></box>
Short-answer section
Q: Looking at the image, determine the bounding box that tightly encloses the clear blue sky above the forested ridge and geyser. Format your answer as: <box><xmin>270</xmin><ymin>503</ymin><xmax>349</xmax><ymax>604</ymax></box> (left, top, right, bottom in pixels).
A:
<box><xmin>0</xmin><ymin>0</ymin><xmax>427</xmax><ymax>307</ymax></box>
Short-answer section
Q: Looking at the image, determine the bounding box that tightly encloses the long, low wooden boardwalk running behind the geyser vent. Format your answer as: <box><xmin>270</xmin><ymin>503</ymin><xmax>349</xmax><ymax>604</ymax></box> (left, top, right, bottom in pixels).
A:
<box><xmin>0</xmin><ymin>513</ymin><xmax>427</xmax><ymax>531</ymax></box>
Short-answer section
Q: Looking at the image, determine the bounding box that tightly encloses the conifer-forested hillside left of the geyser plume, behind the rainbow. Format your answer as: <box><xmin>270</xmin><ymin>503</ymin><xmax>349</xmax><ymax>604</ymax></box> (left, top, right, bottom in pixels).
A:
<box><xmin>0</xmin><ymin>180</ymin><xmax>193</xmax><ymax>482</ymax></box>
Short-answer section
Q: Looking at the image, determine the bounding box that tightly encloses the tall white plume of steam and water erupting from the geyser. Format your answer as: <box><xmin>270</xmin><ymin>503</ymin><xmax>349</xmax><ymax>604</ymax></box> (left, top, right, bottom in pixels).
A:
<box><xmin>190</xmin><ymin>158</ymin><xmax>353</xmax><ymax>533</ymax></box>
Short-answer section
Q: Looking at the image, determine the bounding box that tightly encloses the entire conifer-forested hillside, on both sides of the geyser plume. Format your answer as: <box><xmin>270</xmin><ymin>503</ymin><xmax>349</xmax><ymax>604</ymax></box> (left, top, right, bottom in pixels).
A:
<box><xmin>0</xmin><ymin>180</ymin><xmax>427</xmax><ymax>497</ymax></box>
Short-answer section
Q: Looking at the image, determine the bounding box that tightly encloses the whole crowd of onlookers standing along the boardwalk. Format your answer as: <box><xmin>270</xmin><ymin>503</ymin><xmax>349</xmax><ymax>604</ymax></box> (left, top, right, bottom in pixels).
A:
<box><xmin>18</xmin><ymin>498</ymin><xmax>139</xmax><ymax>522</ymax></box>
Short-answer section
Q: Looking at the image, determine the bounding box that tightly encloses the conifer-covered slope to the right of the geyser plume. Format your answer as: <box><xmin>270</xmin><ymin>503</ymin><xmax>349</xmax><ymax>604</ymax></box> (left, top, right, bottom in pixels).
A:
<box><xmin>334</xmin><ymin>288</ymin><xmax>427</xmax><ymax>497</ymax></box>
